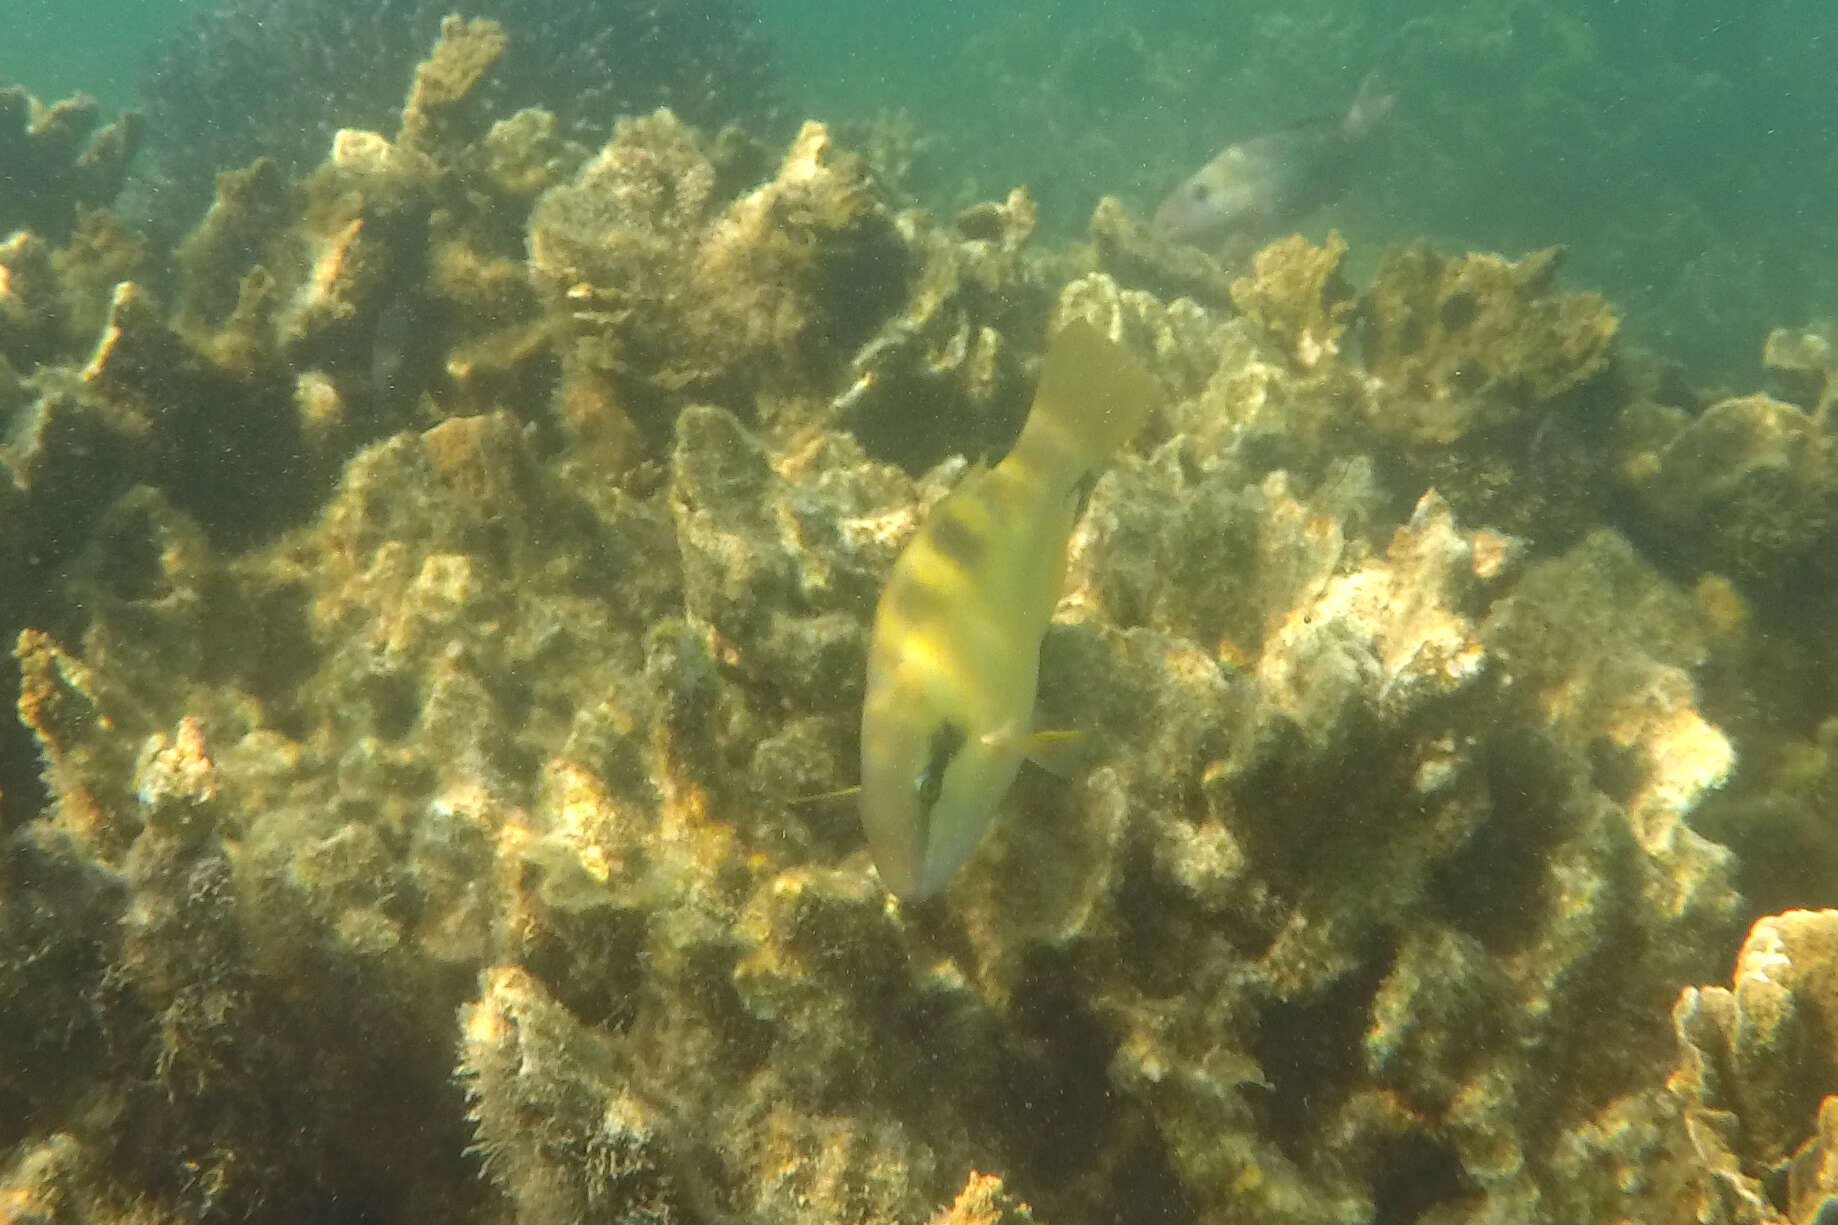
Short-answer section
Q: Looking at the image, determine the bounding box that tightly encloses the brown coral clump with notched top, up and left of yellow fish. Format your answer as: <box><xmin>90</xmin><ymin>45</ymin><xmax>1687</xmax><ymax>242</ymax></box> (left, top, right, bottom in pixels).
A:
<box><xmin>529</xmin><ymin>110</ymin><xmax>908</xmax><ymax>438</ymax></box>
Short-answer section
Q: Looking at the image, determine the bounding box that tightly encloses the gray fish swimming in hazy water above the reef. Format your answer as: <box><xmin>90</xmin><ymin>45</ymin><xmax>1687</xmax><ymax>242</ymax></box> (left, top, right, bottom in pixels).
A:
<box><xmin>1154</xmin><ymin>72</ymin><xmax>1397</xmax><ymax>246</ymax></box>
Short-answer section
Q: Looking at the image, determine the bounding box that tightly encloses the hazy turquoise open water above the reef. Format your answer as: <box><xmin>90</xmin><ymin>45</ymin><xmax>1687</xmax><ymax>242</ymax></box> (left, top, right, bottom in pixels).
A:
<box><xmin>0</xmin><ymin>0</ymin><xmax>1838</xmax><ymax>386</ymax></box>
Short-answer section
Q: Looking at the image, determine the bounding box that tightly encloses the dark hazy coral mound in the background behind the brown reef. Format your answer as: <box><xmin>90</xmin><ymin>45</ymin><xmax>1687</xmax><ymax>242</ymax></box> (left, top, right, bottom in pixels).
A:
<box><xmin>136</xmin><ymin>0</ymin><xmax>777</xmax><ymax>232</ymax></box>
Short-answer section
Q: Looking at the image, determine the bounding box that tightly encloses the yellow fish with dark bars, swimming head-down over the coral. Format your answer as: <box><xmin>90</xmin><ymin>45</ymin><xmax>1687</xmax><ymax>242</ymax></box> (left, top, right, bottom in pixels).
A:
<box><xmin>860</xmin><ymin>322</ymin><xmax>1160</xmax><ymax>898</ymax></box>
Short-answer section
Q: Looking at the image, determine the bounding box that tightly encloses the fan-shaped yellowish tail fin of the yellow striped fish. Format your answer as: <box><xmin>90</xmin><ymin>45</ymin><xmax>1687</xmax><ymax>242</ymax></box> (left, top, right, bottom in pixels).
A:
<box><xmin>1015</xmin><ymin>320</ymin><xmax>1162</xmax><ymax>484</ymax></box>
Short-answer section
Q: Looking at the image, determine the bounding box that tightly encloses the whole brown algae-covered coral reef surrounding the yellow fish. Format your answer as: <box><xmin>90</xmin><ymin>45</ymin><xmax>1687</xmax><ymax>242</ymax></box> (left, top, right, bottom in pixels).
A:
<box><xmin>0</xmin><ymin>18</ymin><xmax>1838</xmax><ymax>1223</ymax></box>
